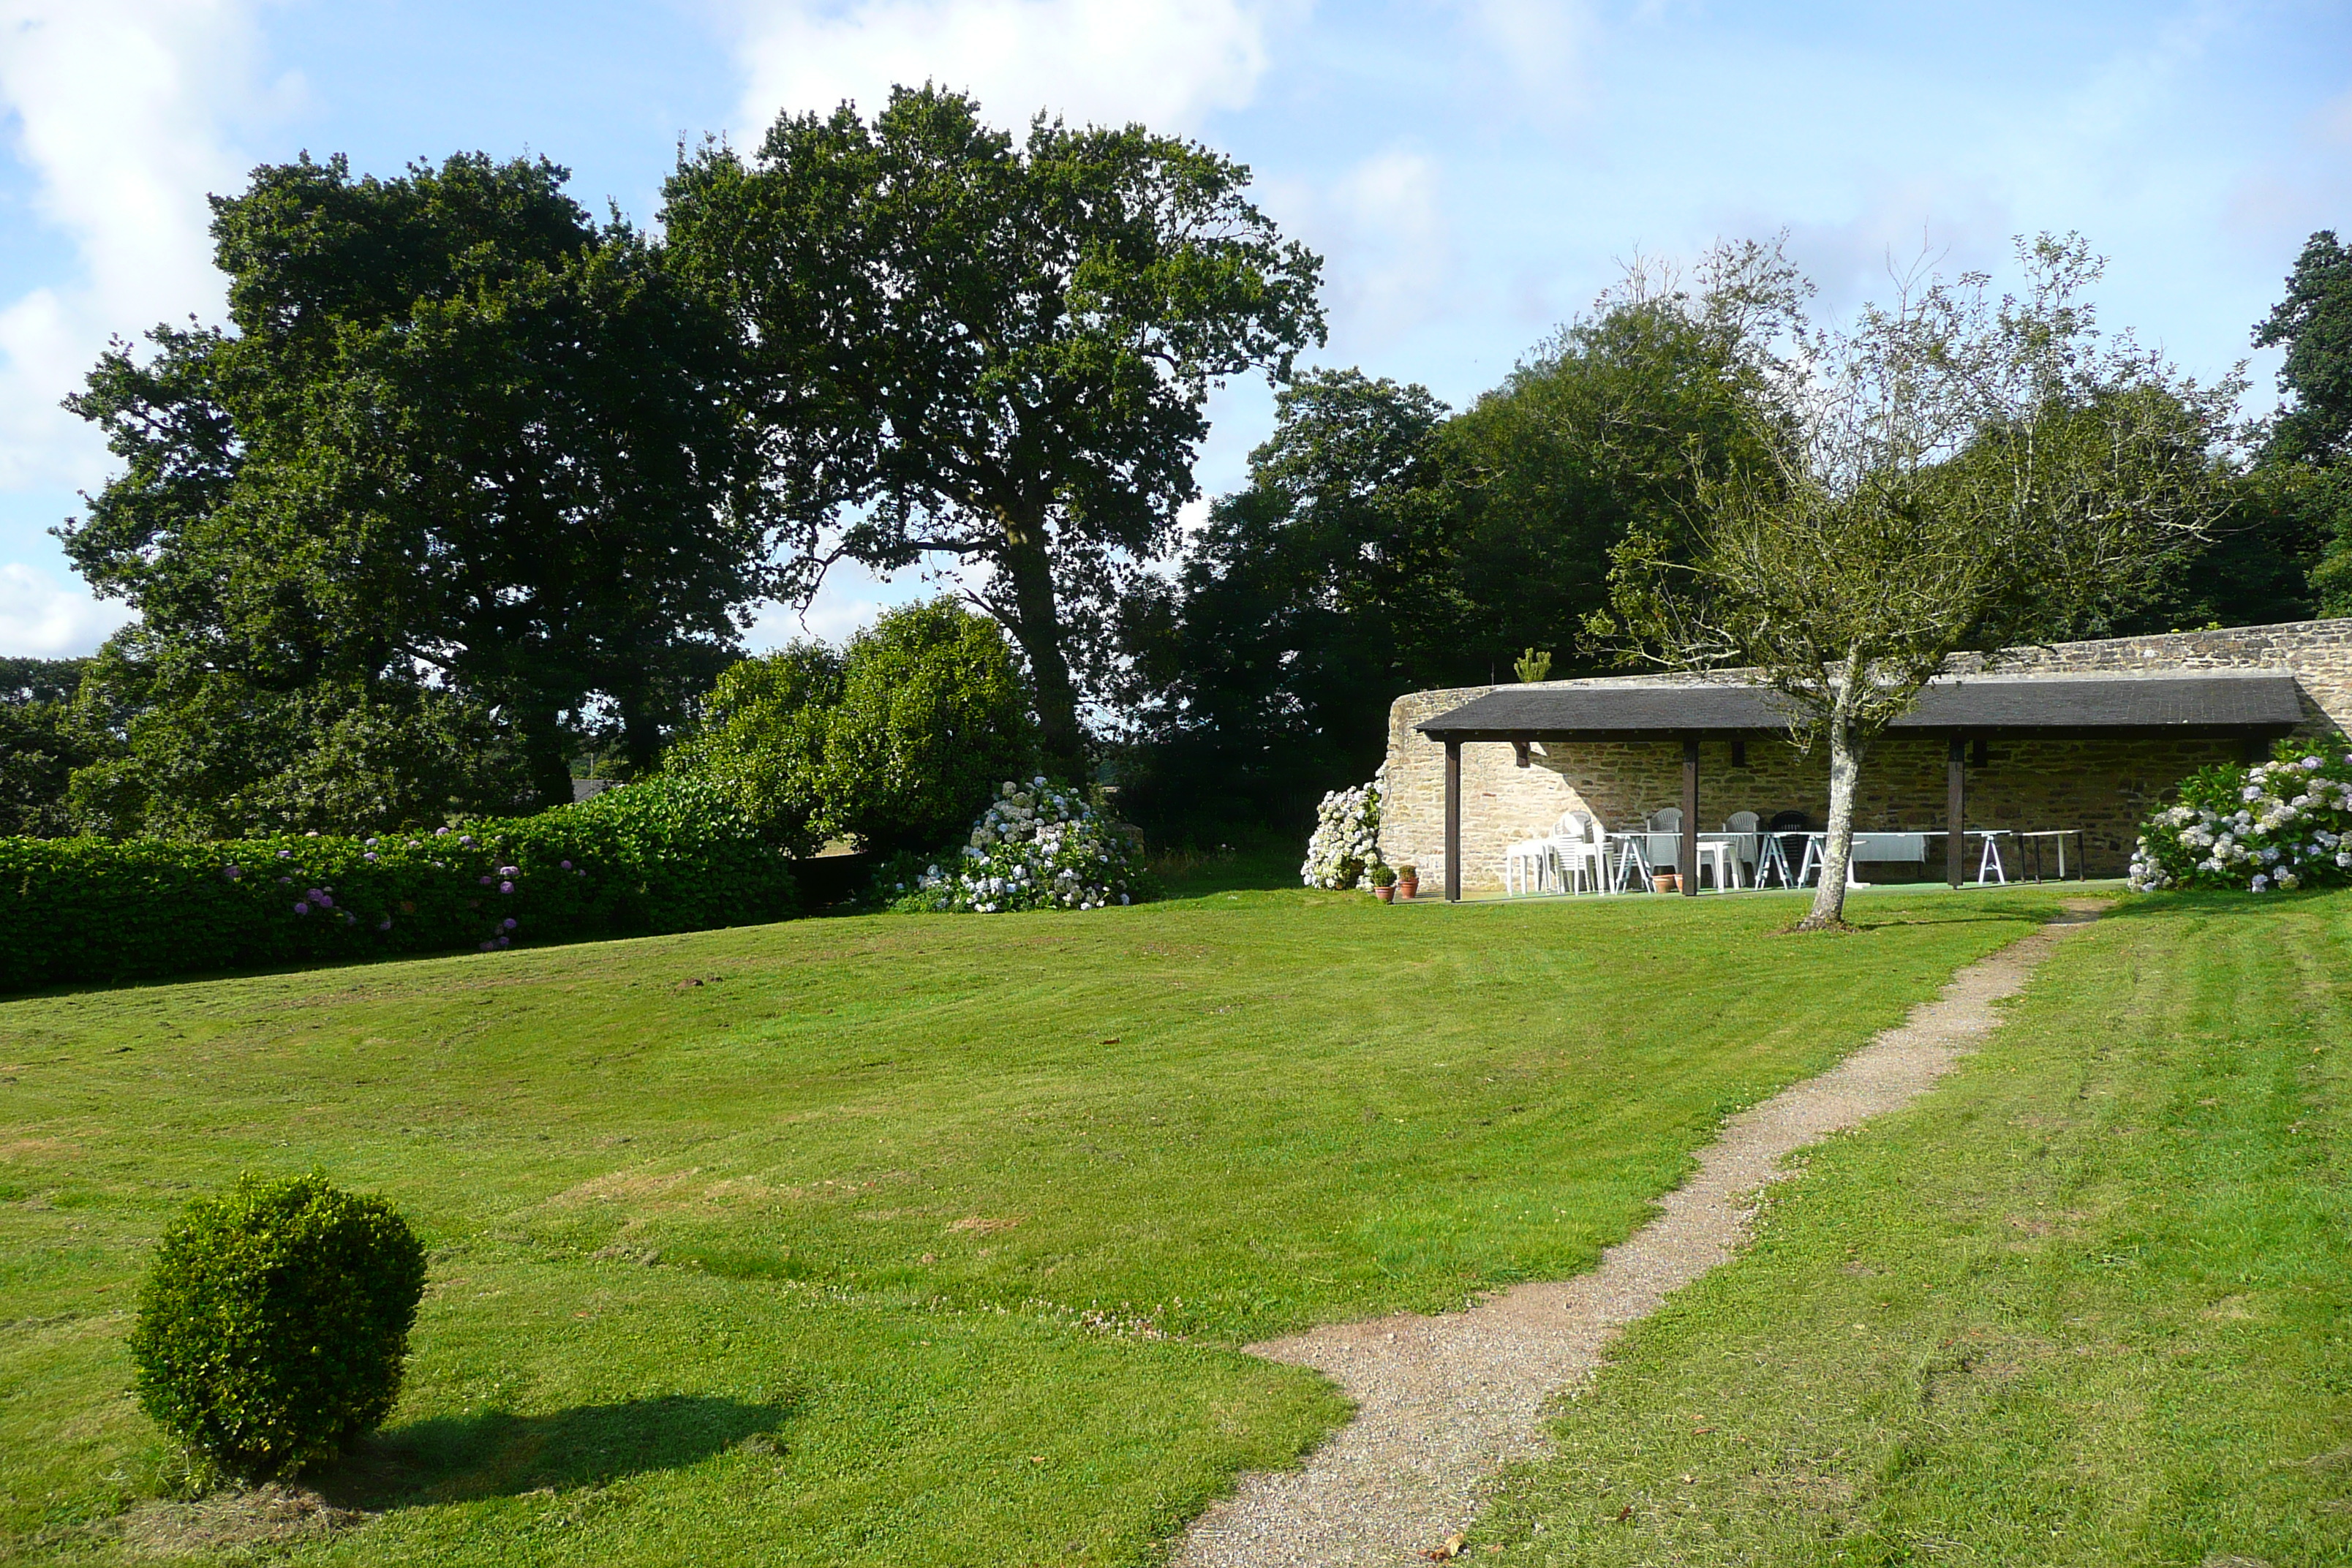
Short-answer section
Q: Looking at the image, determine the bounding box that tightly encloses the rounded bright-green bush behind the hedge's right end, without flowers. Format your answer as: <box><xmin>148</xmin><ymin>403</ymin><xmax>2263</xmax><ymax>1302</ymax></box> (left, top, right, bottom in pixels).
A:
<box><xmin>668</xmin><ymin>600</ymin><xmax>1033</xmax><ymax>853</ymax></box>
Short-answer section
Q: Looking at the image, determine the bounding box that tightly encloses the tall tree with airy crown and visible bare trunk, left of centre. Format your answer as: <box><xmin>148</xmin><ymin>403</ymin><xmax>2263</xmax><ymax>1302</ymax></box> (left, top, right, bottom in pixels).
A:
<box><xmin>663</xmin><ymin>87</ymin><xmax>1324</xmax><ymax>776</ymax></box>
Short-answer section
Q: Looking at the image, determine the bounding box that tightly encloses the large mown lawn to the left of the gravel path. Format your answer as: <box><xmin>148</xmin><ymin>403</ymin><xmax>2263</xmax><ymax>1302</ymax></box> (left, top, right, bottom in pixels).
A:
<box><xmin>0</xmin><ymin>889</ymin><xmax>2054</xmax><ymax>1564</ymax></box>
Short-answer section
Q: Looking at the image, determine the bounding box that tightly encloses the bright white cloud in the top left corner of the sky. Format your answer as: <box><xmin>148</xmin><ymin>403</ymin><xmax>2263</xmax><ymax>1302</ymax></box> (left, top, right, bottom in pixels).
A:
<box><xmin>0</xmin><ymin>0</ymin><xmax>263</xmax><ymax>489</ymax></box>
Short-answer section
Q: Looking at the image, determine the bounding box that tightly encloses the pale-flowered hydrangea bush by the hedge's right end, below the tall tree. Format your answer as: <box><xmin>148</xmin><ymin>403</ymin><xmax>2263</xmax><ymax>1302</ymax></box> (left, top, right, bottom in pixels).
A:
<box><xmin>886</xmin><ymin>778</ymin><xmax>1155</xmax><ymax>914</ymax></box>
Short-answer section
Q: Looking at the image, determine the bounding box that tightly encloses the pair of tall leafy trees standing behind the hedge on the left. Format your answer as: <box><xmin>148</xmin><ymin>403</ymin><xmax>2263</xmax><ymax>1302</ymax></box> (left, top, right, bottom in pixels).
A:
<box><xmin>32</xmin><ymin>89</ymin><xmax>1322</xmax><ymax>834</ymax></box>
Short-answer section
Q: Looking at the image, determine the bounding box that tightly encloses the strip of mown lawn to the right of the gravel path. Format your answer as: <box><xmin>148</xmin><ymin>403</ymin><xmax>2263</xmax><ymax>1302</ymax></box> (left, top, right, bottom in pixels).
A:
<box><xmin>1480</xmin><ymin>893</ymin><xmax>2352</xmax><ymax>1568</ymax></box>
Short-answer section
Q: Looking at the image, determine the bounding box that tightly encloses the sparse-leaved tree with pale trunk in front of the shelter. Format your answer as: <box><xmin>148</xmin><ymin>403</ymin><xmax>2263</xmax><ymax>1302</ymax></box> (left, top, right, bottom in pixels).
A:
<box><xmin>1590</xmin><ymin>235</ymin><xmax>2244</xmax><ymax>929</ymax></box>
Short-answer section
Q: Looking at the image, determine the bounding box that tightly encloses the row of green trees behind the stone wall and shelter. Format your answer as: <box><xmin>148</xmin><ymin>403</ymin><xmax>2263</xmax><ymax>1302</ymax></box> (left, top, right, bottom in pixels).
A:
<box><xmin>1115</xmin><ymin>235</ymin><xmax>2352</xmax><ymax>840</ymax></box>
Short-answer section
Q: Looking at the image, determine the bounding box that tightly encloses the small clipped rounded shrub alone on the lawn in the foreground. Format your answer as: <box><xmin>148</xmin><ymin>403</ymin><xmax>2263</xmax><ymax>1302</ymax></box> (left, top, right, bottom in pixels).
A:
<box><xmin>129</xmin><ymin>1175</ymin><xmax>426</xmax><ymax>1481</ymax></box>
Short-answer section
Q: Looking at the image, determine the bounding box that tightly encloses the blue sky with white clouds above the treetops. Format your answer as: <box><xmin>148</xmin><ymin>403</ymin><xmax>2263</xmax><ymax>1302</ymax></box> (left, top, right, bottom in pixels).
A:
<box><xmin>0</xmin><ymin>0</ymin><xmax>2352</xmax><ymax>654</ymax></box>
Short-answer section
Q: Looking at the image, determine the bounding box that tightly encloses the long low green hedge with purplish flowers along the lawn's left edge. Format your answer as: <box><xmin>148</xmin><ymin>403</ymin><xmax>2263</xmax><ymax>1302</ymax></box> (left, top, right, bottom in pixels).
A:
<box><xmin>0</xmin><ymin>776</ymin><xmax>799</xmax><ymax>990</ymax></box>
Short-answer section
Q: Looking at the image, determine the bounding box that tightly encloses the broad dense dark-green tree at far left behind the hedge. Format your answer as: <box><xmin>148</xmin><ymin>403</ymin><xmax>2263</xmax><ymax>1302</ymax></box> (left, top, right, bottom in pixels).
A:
<box><xmin>59</xmin><ymin>155</ymin><xmax>772</xmax><ymax>827</ymax></box>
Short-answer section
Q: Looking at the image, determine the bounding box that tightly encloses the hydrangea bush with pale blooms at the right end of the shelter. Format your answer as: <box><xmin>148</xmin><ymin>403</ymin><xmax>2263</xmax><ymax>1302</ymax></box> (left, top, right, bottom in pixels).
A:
<box><xmin>2131</xmin><ymin>741</ymin><xmax>2352</xmax><ymax>893</ymax></box>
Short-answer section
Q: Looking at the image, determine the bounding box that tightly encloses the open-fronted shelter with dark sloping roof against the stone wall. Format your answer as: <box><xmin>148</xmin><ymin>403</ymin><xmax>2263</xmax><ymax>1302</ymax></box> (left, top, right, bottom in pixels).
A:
<box><xmin>1383</xmin><ymin>670</ymin><xmax>2302</xmax><ymax>900</ymax></box>
